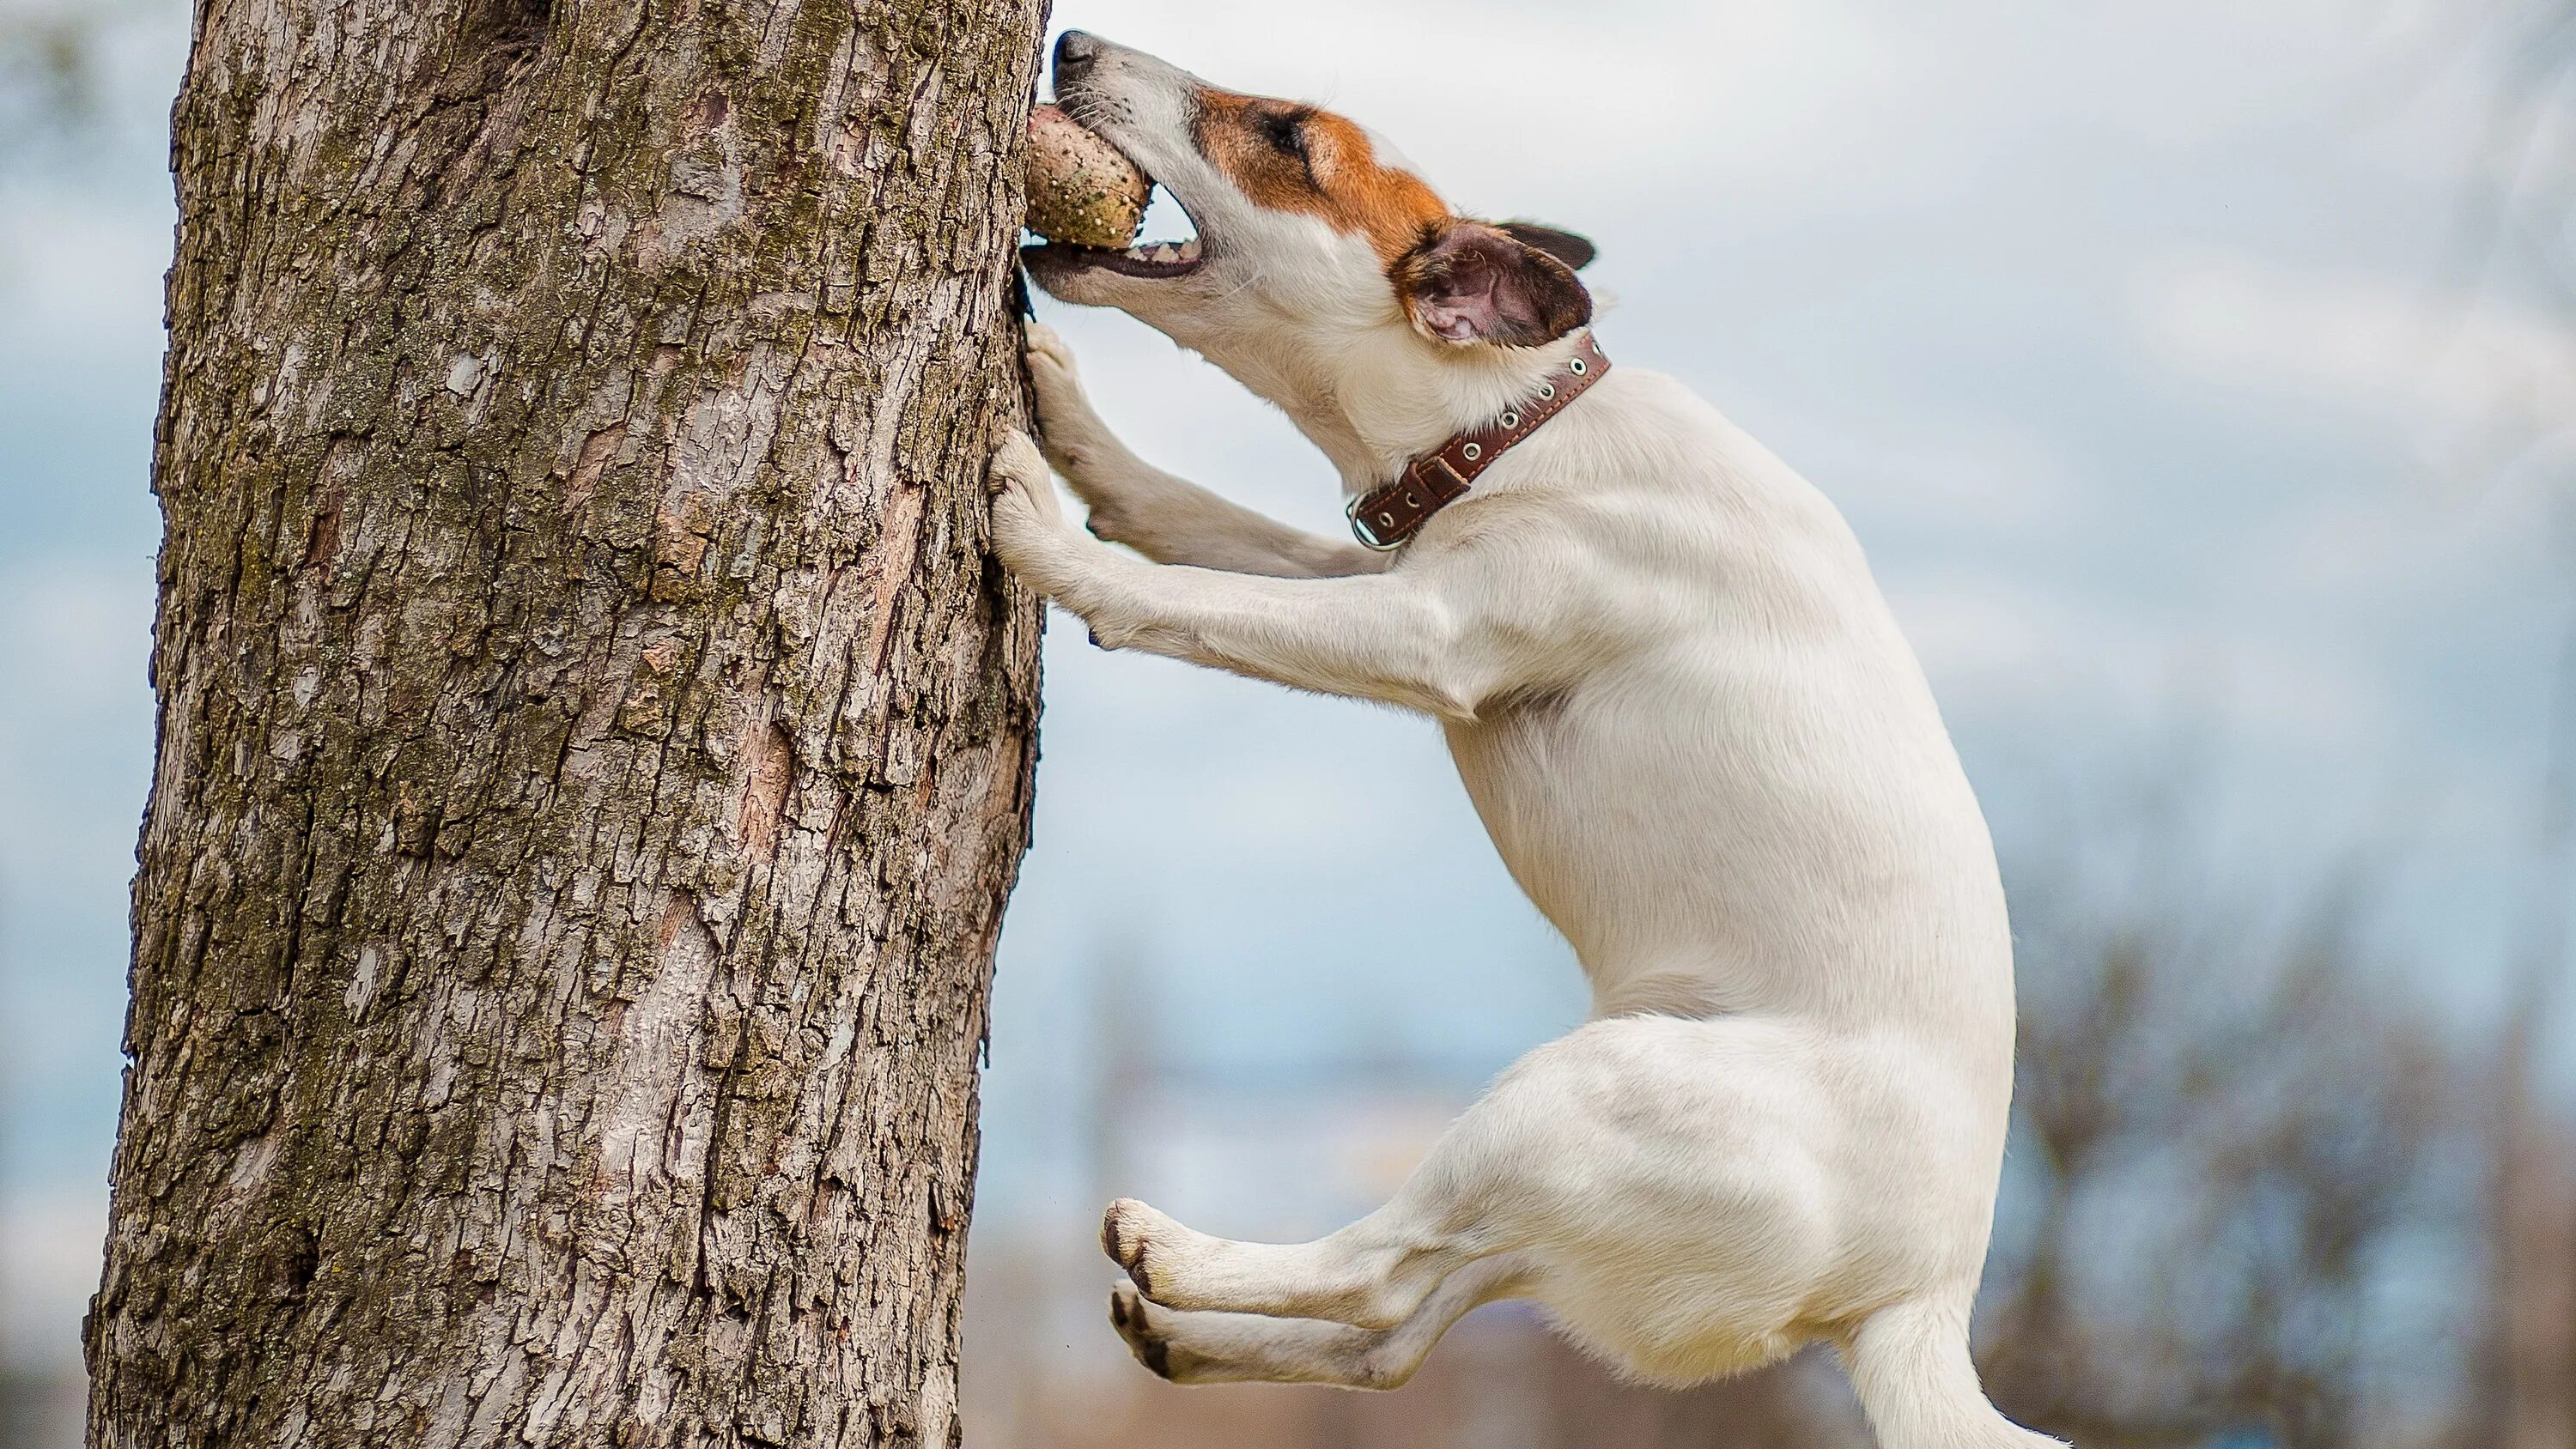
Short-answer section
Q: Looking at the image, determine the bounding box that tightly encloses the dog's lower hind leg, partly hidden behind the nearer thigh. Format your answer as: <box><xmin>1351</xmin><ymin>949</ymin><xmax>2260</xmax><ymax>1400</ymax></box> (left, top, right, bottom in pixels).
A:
<box><xmin>1110</xmin><ymin>1253</ymin><xmax>1533</xmax><ymax>1390</ymax></box>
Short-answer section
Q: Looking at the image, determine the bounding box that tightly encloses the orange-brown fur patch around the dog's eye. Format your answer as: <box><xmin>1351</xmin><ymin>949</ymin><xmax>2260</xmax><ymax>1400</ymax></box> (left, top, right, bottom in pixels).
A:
<box><xmin>1195</xmin><ymin>88</ymin><xmax>1450</xmax><ymax>268</ymax></box>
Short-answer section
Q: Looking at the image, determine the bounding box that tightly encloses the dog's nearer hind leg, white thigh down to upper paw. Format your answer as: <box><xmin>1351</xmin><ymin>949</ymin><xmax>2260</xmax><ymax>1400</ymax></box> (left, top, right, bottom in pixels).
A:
<box><xmin>1100</xmin><ymin>1019</ymin><xmax>1834</xmax><ymax>1338</ymax></box>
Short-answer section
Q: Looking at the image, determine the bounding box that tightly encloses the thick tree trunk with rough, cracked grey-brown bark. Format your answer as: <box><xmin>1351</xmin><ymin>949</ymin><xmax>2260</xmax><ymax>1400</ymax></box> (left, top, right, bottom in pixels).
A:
<box><xmin>88</xmin><ymin>0</ymin><xmax>1043</xmax><ymax>1449</ymax></box>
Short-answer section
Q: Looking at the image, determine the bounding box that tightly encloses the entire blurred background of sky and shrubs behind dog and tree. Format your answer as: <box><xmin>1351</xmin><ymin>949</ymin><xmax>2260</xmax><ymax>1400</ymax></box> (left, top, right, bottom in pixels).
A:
<box><xmin>0</xmin><ymin>0</ymin><xmax>2576</xmax><ymax>1449</ymax></box>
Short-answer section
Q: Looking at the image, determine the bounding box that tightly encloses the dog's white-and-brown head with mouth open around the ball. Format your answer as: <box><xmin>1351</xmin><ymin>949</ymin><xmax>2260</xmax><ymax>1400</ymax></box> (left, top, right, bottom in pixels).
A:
<box><xmin>1025</xmin><ymin>31</ymin><xmax>1592</xmax><ymax>424</ymax></box>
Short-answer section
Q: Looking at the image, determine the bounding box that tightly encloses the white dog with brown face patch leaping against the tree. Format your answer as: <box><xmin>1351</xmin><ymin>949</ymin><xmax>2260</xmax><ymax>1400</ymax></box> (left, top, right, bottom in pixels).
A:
<box><xmin>992</xmin><ymin>31</ymin><xmax>2056</xmax><ymax>1449</ymax></box>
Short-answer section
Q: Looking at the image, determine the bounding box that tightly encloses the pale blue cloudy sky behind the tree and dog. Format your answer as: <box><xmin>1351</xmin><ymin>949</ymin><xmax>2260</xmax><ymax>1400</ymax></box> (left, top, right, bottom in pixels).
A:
<box><xmin>0</xmin><ymin>0</ymin><xmax>2576</xmax><ymax>1364</ymax></box>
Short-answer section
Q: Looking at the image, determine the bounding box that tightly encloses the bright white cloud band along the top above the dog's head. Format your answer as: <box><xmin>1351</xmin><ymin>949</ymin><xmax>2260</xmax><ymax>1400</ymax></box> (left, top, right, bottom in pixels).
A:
<box><xmin>1054</xmin><ymin>0</ymin><xmax>2476</xmax><ymax>229</ymax></box>
